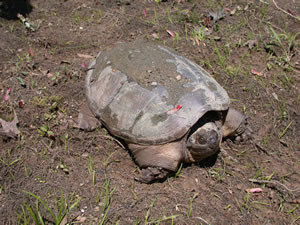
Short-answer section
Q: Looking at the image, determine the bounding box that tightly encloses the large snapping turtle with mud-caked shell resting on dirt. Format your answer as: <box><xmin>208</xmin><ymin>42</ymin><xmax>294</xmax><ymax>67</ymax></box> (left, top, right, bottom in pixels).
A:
<box><xmin>86</xmin><ymin>42</ymin><xmax>251</xmax><ymax>183</ymax></box>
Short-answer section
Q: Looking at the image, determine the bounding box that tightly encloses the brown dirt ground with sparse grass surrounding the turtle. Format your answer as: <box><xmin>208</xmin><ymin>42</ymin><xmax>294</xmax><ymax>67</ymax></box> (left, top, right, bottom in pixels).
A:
<box><xmin>0</xmin><ymin>0</ymin><xmax>300</xmax><ymax>225</ymax></box>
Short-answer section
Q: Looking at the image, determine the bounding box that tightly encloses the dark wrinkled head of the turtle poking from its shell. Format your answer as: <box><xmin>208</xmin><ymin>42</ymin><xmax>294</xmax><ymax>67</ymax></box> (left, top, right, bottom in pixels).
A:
<box><xmin>186</xmin><ymin>122</ymin><xmax>222</xmax><ymax>162</ymax></box>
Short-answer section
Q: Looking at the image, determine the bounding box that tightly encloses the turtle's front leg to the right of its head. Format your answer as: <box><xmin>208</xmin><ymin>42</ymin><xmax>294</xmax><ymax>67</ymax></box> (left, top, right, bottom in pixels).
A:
<box><xmin>222</xmin><ymin>108</ymin><xmax>253</xmax><ymax>142</ymax></box>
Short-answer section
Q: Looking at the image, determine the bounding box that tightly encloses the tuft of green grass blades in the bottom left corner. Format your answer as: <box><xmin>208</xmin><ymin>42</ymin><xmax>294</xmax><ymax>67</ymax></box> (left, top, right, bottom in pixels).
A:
<box><xmin>18</xmin><ymin>191</ymin><xmax>80</xmax><ymax>225</ymax></box>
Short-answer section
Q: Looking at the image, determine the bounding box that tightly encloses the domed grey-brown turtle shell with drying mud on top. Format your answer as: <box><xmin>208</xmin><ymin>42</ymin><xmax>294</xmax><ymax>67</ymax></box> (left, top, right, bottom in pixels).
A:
<box><xmin>86</xmin><ymin>42</ymin><xmax>229</xmax><ymax>145</ymax></box>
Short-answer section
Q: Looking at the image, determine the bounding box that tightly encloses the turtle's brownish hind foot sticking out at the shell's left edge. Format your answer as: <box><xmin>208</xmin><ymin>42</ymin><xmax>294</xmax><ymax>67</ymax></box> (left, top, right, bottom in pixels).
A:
<box><xmin>77</xmin><ymin>103</ymin><xmax>101</xmax><ymax>131</ymax></box>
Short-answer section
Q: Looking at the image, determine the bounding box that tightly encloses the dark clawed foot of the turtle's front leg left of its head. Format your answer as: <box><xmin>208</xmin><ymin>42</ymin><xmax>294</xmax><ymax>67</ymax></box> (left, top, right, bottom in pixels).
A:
<box><xmin>134</xmin><ymin>167</ymin><xmax>169</xmax><ymax>184</ymax></box>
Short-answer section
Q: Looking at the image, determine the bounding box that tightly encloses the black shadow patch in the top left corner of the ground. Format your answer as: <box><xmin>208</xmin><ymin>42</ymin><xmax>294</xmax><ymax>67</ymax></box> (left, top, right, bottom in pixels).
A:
<box><xmin>0</xmin><ymin>0</ymin><xmax>32</xmax><ymax>20</ymax></box>
